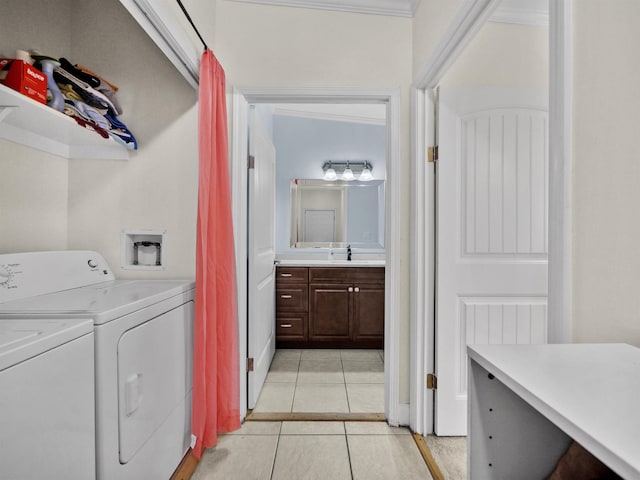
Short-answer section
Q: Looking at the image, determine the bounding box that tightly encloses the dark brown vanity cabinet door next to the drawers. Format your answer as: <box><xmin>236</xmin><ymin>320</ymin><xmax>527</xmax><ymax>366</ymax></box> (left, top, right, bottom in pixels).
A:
<box><xmin>309</xmin><ymin>283</ymin><xmax>351</xmax><ymax>341</ymax></box>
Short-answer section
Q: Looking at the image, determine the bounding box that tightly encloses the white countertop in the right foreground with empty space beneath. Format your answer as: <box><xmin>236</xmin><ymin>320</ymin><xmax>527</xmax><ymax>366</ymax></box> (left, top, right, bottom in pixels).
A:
<box><xmin>468</xmin><ymin>344</ymin><xmax>640</xmax><ymax>478</ymax></box>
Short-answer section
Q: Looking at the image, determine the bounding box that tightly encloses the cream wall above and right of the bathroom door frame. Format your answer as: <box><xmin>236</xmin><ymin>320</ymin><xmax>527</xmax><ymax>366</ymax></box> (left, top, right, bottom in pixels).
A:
<box><xmin>215</xmin><ymin>0</ymin><xmax>412</xmax><ymax>403</ymax></box>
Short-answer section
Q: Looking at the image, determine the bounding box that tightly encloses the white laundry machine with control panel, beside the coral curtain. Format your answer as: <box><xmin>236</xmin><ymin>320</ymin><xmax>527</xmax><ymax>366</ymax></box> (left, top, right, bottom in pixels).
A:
<box><xmin>0</xmin><ymin>251</ymin><xmax>195</xmax><ymax>480</ymax></box>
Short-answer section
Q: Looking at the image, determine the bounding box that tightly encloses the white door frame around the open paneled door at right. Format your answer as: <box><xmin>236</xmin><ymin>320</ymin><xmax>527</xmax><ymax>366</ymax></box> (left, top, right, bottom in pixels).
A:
<box><xmin>410</xmin><ymin>0</ymin><xmax>573</xmax><ymax>434</ymax></box>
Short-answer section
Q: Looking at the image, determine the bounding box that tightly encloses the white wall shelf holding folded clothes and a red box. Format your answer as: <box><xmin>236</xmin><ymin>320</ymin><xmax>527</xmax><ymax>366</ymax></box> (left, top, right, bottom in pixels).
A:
<box><xmin>0</xmin><ymin>85</ymin><xmax>129</xmax><ymax>160</ymax></box>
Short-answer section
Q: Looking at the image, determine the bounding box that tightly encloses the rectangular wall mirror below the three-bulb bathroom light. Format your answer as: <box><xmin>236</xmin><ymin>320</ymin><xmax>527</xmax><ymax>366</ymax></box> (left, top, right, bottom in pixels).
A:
<box><xmin>291</xmin><ymin>179</ymin><xmax>384</xmax><ymax>250</ymax></box>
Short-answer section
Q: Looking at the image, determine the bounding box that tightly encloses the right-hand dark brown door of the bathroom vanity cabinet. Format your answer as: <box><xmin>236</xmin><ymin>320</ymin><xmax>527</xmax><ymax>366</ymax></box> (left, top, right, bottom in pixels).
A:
<box><xmin>352</xmin><ymin>285</ymin><xmax>384</xmax><ymax>341</ymax></box>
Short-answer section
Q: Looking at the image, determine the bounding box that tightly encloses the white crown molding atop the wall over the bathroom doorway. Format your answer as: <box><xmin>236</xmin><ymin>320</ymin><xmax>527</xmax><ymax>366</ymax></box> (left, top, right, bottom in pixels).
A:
<box><xmin>231</xmin><ymin>0</ymin><xmax>419</xmax><ymax>17</ymax></box>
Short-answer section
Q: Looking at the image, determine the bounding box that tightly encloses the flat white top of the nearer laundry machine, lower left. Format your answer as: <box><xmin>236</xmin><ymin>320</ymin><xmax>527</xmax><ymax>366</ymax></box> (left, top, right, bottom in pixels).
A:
<box><xmin>0</xmin><ymin>319</ymin><xmax>93</xmax><ymax>372</ymax></box>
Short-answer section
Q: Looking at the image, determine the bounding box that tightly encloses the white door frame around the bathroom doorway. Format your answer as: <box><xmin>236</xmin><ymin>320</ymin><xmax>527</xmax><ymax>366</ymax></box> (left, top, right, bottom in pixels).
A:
<box><xmin>230</xmin><ymin>87</ymin><xmax>406</xmax><ymax>425</ymax></box>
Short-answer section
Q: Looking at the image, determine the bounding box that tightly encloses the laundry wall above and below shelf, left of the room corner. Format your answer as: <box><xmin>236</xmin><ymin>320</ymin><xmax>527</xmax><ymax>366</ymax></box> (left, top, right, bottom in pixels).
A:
<box><xmin>0</xmin><ymin>0</ymin><xmax>71</xmax><ymax>253</ymax></box>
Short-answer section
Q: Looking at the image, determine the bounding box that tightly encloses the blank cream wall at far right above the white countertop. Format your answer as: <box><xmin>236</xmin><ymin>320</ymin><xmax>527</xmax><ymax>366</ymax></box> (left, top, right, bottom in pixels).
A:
<box><xmin>572</xmin><ymin>0</ymin><xmax>640</xmax><ymax>346</ymax></box>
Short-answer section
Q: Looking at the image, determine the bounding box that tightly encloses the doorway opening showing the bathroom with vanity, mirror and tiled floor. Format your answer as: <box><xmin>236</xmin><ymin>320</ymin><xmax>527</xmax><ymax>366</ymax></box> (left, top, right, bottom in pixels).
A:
<box><xmin>247</xmin><ymin>103</ymin><xmax>387</xmax><ymax>418</ymax></box>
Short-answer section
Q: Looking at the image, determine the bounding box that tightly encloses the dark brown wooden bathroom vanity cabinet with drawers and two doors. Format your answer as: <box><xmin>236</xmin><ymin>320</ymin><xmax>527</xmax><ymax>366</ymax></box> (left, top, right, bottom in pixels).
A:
<box><xmin>276</xmin><ymin>263</ymin><xmax>385</xmax><ymax>349</ymax></box>
